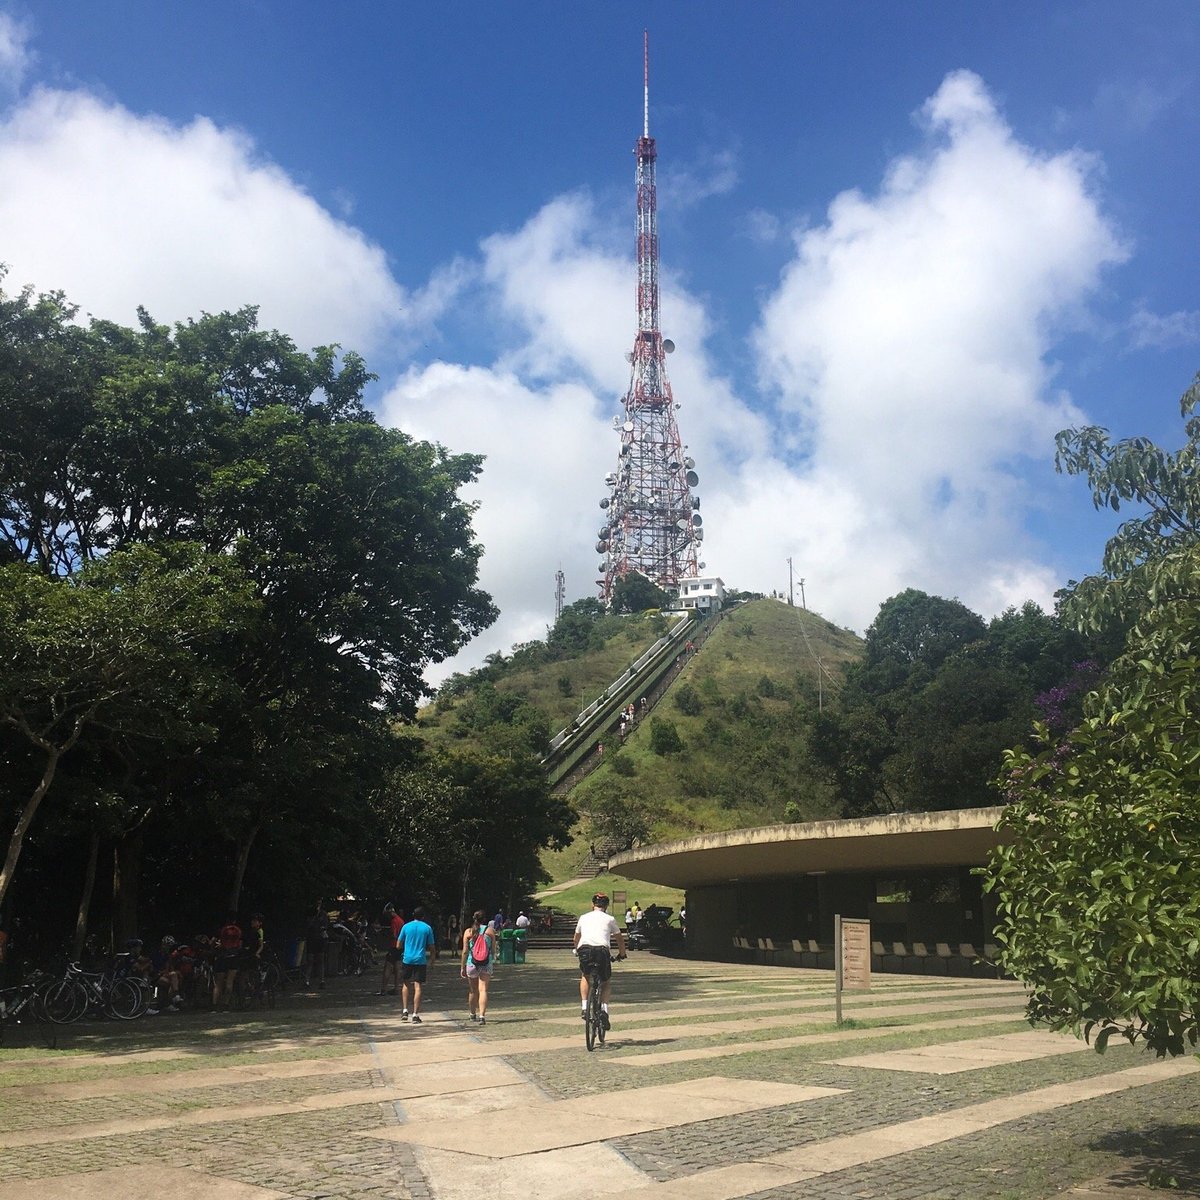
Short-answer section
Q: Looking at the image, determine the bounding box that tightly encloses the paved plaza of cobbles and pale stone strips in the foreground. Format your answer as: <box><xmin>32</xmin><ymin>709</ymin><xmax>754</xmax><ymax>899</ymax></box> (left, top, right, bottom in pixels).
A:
<box><xmin>0</xmin><ymin>948</ymin><xmax>1200</xmax><ymax>1200</ymax></box>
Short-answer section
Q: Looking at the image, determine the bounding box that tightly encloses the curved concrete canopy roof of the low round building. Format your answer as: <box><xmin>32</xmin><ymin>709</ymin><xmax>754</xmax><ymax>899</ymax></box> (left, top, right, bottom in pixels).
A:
<box><xmin>608</xmin><ymin>808</ymin><xmax>1003</xmax><ymax>888</ymax></box>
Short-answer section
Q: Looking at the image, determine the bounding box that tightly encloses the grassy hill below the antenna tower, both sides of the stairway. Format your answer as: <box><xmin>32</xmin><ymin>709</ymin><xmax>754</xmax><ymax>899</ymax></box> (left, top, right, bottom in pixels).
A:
<box><xmin>419</xmin><ymin>600</ymin><xmax>863</xmax><ymax>882</ymax></box>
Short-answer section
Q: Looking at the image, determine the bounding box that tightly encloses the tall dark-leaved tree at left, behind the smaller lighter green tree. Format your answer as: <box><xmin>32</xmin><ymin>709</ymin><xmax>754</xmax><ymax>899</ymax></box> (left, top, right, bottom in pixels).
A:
<box><xmin>0</xmin><ymin>278</ymin><xmax>494</xmax><ymax>936</ymax></box>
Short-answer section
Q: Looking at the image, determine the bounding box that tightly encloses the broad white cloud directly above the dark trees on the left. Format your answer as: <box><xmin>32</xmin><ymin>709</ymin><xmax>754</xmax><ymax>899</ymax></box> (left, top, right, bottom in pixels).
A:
<box><xmin>0</xmin><ymin>89</ymin><xmax>404</xmax><ymax>350</ymax></box>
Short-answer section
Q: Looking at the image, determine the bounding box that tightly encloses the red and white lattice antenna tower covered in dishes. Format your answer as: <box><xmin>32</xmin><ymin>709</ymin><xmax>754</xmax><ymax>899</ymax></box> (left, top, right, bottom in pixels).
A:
<box><xmin>596</xmin><ymin>34</ymin><xmax>704</xmax><ymax>602</ymax></box>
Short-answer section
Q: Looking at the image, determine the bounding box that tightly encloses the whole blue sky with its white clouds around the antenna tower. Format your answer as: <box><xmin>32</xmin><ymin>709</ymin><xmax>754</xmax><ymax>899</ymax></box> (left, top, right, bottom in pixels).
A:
<box><xmin>0</xmin><ymin>0</ymin><xmax>1200</xmax><ymax>666</ymax></box>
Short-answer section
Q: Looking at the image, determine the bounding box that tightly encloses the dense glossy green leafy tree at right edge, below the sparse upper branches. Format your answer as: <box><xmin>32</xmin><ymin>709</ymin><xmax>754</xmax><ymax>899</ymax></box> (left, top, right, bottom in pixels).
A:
<box><xmin>986</xmin><ymin>546</ymin><xmax>1200</xmax><ymax>1055</ymax></box>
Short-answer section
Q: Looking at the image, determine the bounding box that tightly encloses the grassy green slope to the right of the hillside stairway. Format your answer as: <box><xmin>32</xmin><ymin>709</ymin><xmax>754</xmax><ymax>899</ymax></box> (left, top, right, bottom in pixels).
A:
<box><xmin>571</xmin><ymin>600</ymin><xmax>863</xmax><ymax>844</ymax></box>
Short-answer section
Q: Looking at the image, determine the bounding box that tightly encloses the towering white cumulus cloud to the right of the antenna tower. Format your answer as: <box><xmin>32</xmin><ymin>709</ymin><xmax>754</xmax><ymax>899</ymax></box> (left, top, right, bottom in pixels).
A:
<box><xmin>739</xmin><ymin>71</ymin><xmax>1126</xmax><ymax>628</ymax></box>
